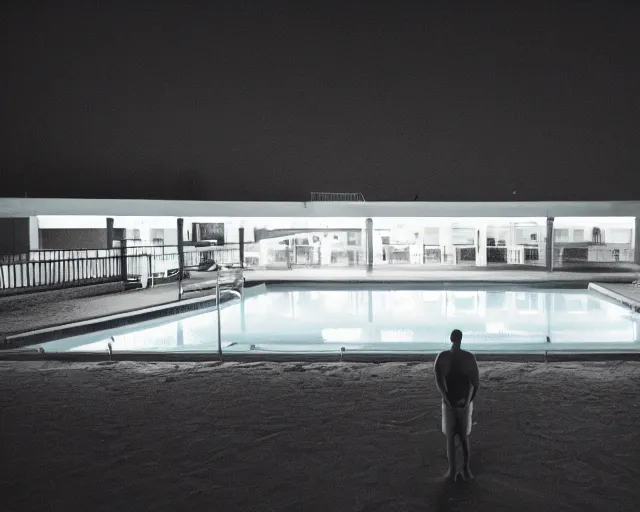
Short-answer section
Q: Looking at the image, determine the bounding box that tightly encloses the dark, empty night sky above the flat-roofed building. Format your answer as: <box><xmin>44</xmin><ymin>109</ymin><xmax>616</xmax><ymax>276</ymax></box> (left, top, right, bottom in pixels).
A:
<box><xmin>0</xmin><ymin>0</ymin><xmax>640</xmax><ymax>200</ymax></box>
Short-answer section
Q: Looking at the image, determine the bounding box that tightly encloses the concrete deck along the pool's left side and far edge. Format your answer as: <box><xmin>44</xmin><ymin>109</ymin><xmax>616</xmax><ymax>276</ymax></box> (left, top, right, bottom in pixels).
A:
<box><xmin>0</xmin><ymin>268</ymin><xmax>638</xmax><ymax>348</ymax></box>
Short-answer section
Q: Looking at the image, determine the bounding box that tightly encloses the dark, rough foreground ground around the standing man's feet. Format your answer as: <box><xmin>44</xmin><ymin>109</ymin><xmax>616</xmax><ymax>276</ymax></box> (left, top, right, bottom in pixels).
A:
<box><xmin>0</xmin><ymin>362</ymin><xmax>640</xmax><ymax>512</ymax></box>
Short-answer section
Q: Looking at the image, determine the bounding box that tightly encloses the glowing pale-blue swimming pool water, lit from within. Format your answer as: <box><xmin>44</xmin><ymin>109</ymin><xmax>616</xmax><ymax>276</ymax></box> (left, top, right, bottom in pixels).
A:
<box><xmin>40</xmin><ymin>284</ymin><xmax>640</xmax><ymax>354</ymax></box>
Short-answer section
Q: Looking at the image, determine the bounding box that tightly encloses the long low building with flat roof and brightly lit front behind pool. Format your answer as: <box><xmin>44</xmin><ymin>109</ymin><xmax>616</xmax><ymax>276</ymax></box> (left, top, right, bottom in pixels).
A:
<box><xmin>0</xmin><ymin>198</ymin><xmax>640</xmax><ymax>288</ymax></box>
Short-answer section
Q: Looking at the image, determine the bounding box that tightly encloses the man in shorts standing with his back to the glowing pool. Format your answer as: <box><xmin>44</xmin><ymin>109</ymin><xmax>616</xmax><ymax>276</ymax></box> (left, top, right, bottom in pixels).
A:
<box><xmin>435</xmin><ymin>329</ymin><xmax>480</xmax><ymax>481</ymax></box>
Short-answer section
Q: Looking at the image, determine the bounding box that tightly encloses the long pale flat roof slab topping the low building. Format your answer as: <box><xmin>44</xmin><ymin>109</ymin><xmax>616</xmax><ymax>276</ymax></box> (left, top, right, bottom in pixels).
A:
<box><xmin>0</xmin><ymin>198</ymin><xmax>640</xmax><ymax>218</ymax></box>
